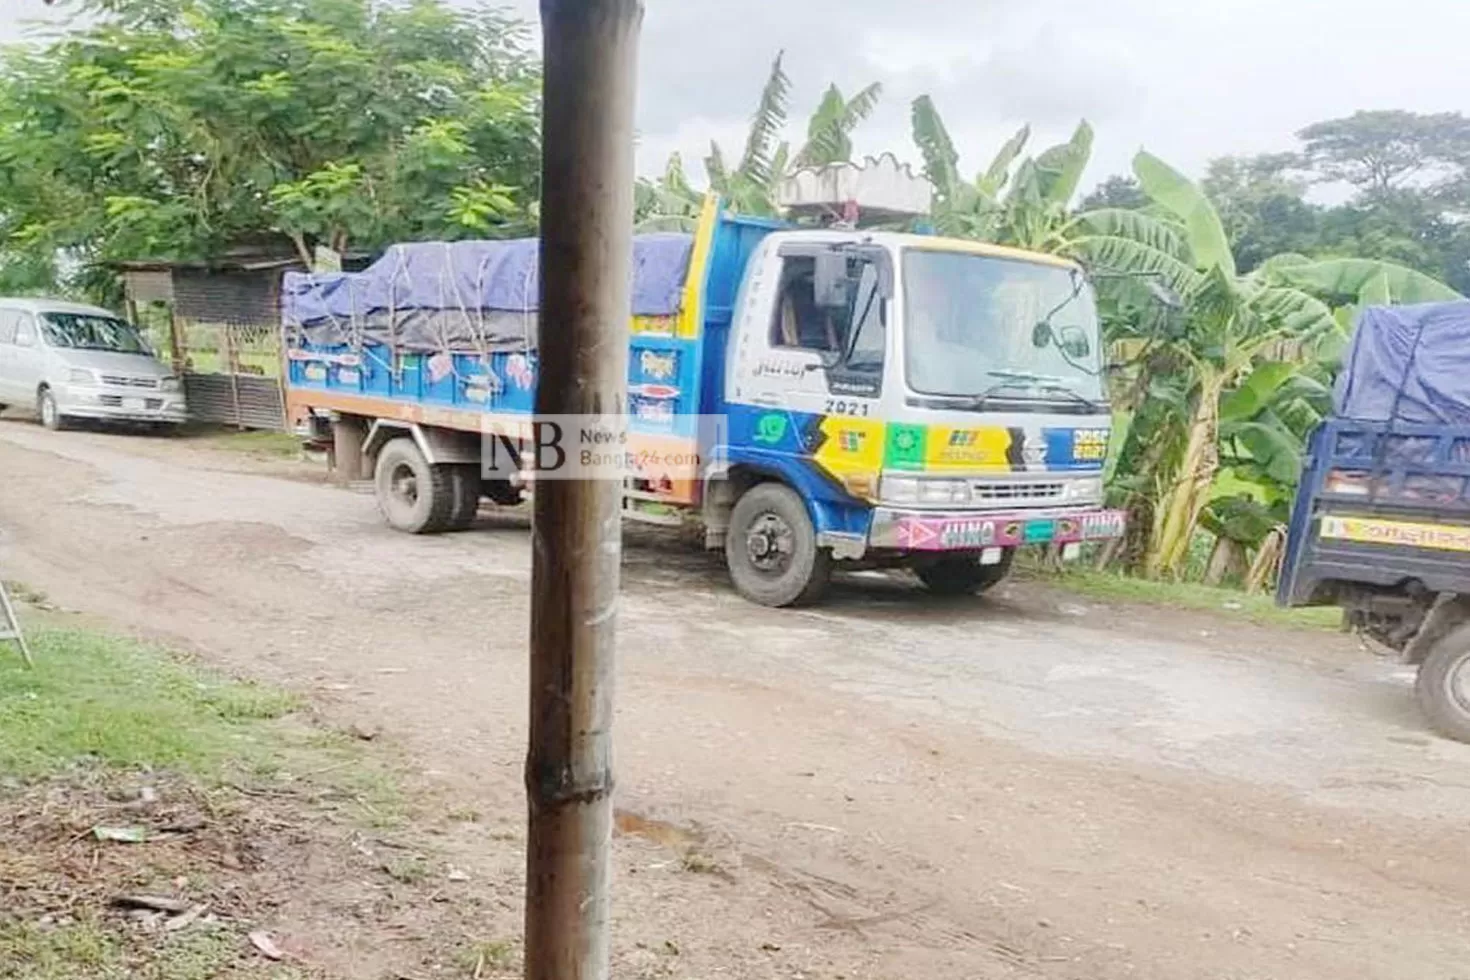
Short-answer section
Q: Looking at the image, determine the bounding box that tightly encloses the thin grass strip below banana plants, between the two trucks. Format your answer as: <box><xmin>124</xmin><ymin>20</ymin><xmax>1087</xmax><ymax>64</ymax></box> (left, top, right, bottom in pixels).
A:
<box><xmin>1025</xmin><ymin>567</ymin><xmax>1342</xmax><ymax>630</ymax></box>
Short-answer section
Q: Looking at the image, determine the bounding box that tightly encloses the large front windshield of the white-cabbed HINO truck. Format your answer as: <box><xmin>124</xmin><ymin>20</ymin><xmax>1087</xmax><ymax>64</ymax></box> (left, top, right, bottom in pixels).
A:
<box><xmin>903</xmin><ymin>248</ymin><xmax>1103</xmax><ymax>403</ymax></box>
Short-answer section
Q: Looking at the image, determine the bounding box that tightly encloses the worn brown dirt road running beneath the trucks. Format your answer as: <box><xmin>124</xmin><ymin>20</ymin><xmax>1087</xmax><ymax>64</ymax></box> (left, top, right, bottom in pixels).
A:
<box><xmin>0</xmin><ymin>422</ymin><xmax>1470</xmax><ymax>980</ymax></box>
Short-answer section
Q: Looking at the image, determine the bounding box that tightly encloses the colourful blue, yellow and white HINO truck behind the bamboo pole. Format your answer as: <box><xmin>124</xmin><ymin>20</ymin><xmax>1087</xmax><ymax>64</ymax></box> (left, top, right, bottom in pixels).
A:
<box><xmin>282</xmin><ymin>195</ymin><xmax>1123</xmax><ymax>607</ymax></box>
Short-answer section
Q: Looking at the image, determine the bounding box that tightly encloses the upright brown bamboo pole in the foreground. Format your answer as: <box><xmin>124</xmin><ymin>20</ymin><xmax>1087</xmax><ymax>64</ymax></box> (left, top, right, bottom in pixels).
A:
<box><xmin>525</xmin><ymin>0</ymin><xmax>642</xmax><ymax>980</ymax></box>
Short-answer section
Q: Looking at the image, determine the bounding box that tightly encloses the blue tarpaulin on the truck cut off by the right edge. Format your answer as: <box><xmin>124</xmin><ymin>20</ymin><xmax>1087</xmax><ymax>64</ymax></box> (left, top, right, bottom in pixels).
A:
<box><xmin>1333</xmin><ymin>301</ymin><xmax>1470</xmax><ymax>426</ymax></box>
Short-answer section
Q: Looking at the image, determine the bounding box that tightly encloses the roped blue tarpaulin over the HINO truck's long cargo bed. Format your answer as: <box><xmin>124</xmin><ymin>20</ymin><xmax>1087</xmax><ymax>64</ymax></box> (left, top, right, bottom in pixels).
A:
<box><xmin>281</xmin><ymin>234</ymin><xmax>694</xmax><ymax>351</ymax></box>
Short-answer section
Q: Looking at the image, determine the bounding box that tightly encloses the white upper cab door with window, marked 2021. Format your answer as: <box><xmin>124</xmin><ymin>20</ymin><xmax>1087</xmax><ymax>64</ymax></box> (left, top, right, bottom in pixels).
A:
<box><xmin>732</xmin><ymin>247</ymin><xmax>888</xmax><ymax>417</ymax></box>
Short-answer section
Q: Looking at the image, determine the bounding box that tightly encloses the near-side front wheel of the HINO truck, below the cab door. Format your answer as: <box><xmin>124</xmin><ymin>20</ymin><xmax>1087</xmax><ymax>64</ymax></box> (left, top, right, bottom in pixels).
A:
<box><xmin>725</xmin><ymin>483</ymin><xmax>832</xmax><ymax>607</ymax></box>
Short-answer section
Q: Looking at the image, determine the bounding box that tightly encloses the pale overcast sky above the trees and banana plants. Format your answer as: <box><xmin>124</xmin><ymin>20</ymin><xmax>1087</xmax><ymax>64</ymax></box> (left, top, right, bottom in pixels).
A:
<box><xmin>0</xmin><ymin>0</ymin><xmax>1470</xmax><ymax>199</ymax></box>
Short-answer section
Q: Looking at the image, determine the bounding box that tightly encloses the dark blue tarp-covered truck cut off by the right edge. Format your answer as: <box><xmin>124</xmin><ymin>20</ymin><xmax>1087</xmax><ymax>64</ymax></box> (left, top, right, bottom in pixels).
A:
<box><xmin>1277</xmin><ymin>301</ymin><xmax>1470</xmax><ymax>742</ymax></box>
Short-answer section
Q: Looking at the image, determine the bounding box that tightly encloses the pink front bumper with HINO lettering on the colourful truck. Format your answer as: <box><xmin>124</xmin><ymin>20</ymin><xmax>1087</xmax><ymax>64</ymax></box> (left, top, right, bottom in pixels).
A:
<box><xmin>867</xmin><ymin>507</ymin><xmax>1127</xmax><ymax>551</ymax></box>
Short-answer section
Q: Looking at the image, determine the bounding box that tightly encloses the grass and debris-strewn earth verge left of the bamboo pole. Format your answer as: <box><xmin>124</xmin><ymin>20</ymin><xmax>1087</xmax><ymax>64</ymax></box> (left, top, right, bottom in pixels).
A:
<box><xmin>0</xmin><ymin>599</ymin><xmax>516</xmax><ymax>980</ymax></box>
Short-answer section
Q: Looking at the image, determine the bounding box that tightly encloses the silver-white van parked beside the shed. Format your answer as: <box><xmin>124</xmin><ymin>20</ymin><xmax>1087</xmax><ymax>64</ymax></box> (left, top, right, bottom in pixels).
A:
<box><xmin>0</xmin><ymin>298</ymin><xmax>187</xmax><ymax>429</ymax></box>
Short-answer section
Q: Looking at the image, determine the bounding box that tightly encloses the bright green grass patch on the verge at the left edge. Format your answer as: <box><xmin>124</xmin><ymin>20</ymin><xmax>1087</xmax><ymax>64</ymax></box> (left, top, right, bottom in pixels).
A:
<box><xmin>0</xmin><ymin>629</ymin><xmax>297</xmax><ymax>779</ymax></box>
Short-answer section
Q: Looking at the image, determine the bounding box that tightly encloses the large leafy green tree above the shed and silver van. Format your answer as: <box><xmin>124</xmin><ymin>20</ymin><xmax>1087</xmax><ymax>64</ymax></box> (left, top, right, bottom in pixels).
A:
<box><xmin>0</xmin><ymin>0</ymin><xmax>539</xmax><ymax>288</ymax></box>
